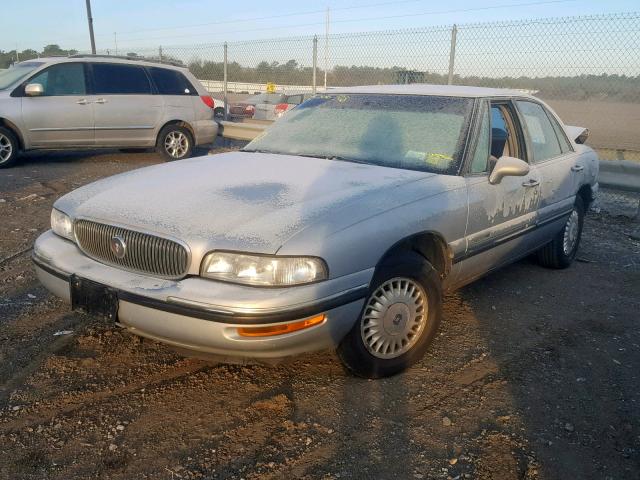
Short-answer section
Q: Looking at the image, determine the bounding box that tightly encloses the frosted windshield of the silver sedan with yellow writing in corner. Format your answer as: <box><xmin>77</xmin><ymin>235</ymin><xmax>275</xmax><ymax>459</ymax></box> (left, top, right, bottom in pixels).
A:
<box><xmin>244</xmin><ymin>94</ymin><xmax>473</xmax><ymax>175</ymax></box>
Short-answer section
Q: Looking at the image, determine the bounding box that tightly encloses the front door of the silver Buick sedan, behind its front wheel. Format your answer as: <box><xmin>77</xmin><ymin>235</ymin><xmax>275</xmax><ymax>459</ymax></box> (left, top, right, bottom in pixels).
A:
<box><xmin>460</xmin><ymin>100</ymin><xmax>540</xmax><ymax>283</ymax></box>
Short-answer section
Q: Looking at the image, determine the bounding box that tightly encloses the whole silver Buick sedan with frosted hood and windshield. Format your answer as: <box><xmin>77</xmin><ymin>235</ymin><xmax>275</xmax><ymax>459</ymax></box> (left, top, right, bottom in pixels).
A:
<box><xmin>33</xmin><ymin>85</ymin><xmax>598</xmax><ymax>377</ymax></box>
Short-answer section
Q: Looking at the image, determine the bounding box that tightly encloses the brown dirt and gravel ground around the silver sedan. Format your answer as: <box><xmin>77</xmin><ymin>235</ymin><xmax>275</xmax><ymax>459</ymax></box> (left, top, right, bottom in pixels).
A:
<box><xmin>0</xmin><ymin>148</ymin><xmax>640</xmax><ymax>480</ymax></box>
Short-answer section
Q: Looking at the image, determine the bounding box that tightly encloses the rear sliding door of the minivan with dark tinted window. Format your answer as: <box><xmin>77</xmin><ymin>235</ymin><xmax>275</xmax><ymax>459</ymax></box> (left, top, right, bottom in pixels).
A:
<box><xmin>91</xmin><ymin>62</ymin><xmax>164</xmax><ymax>147</ymax></box>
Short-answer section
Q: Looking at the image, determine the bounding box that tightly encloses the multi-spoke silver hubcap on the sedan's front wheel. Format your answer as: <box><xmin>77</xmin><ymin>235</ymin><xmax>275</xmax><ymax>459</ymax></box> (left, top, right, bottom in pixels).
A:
<box><xmin>360</xmin><ymin>277</ymin><xmax>428</xmax><ymax>359</ymax></box>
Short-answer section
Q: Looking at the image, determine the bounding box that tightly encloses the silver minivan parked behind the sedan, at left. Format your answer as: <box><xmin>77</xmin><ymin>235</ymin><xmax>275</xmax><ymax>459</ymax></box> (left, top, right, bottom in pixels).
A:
<box><xmin>0</xmin><ymin>55</ymin><xmax>224</xmax><ymax>168</ymax></box>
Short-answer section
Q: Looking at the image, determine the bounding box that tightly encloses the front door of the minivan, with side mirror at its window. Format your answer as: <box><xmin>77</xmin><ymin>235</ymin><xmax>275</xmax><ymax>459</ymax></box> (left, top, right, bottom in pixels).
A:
<box><xmin>21</xmin><ymin>62</ymin><xmax>94</xmax><ymax>148</ymax></box>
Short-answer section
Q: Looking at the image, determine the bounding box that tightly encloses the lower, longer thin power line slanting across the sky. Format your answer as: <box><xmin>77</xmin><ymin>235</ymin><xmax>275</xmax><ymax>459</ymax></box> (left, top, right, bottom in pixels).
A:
<box><xmin>116</xmin><ymin>0</ymin><xmax>579</xmax><ymax>46</ymax></box>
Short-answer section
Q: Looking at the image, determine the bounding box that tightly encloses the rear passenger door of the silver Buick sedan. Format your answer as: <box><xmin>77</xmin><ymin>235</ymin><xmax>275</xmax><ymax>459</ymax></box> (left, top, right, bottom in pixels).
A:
<box><xmin>515</xmin><ymin>99</ymin><xmax>584</xmax><ymax>225</ymax></box>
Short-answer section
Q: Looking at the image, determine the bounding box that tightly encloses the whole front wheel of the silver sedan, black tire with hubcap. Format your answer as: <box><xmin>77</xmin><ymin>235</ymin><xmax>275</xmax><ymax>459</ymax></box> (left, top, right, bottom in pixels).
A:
<box><xmin>338</xmin><ymin>252</ymin><xmax>442</xmax><ymax>378</ymax></box>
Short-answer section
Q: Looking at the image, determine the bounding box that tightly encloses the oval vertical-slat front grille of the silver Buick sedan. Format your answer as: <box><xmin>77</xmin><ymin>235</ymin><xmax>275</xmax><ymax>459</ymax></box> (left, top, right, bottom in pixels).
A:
<box><xmin>74</xmin><ymin>220</ymin><xmax>189</xmax><ymax>278</ymax></box>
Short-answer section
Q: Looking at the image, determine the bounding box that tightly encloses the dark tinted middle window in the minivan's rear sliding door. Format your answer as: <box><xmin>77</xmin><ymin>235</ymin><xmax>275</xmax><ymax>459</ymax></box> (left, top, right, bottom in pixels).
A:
<box><xmin>92</xmin><ymin>63</ymin><xmax>151</xmax><ymax>95</ymax></box>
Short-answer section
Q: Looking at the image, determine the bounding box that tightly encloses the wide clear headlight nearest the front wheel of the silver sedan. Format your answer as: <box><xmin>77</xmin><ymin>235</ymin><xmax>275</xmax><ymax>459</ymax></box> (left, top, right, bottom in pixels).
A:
<box><xmin>200</xmin><ymin>252</ymin><xmax>328</xmax><ymax>287</ymax></box>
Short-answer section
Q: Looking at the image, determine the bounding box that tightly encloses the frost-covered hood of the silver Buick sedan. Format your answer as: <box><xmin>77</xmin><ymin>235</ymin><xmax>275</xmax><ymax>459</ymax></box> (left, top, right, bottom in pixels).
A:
<box><xmin>55</xmin><ymin>152</ymin><xmax>434</xmax><ymax>253</ymax></box>
